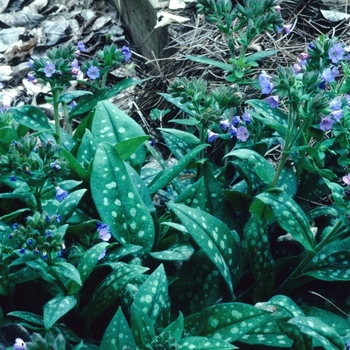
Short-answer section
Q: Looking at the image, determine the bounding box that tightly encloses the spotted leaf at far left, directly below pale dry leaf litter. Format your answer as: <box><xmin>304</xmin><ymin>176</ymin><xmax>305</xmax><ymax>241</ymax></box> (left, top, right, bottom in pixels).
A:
<box><xmin>10</xmin><ymin>105</ymin><xmax>52</xmax><ymax>132</ymax></box>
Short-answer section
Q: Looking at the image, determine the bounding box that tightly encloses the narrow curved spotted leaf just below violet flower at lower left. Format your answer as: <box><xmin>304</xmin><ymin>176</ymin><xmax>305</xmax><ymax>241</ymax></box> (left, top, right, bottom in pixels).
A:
<box><xmin>67</xmin><ymin>242</ymin><xmax>109</xmax><ymax>294</ymax></box>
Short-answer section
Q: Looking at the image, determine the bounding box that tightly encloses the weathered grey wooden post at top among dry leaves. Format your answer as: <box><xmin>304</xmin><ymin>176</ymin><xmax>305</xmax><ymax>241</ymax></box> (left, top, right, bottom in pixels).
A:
<box><xmin>109</xmin><ymin>0</ymin><xmax>169</xmax><ymax>60</ymax></box>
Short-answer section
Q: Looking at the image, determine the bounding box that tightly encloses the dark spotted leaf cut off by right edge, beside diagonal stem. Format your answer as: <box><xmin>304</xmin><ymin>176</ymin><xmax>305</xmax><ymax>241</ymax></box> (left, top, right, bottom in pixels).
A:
<box><xmin>302</xmin><ymin>237</ymin><xmax>350</xmax><ymax>281</ymax></box>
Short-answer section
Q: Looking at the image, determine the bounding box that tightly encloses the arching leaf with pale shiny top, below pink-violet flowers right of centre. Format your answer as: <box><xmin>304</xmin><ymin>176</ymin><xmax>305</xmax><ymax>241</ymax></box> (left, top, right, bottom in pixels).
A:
<box><xmin>224</xmin><ymin>148</ymin><xmax>275</xmax><ymax>185</ymax></box>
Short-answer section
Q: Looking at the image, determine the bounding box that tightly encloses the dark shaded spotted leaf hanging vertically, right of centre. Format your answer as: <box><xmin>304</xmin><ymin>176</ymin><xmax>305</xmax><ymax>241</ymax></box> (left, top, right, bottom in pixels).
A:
<box><xmin>244</xmin><ymin>215</ymin><xmax>275</xmax><ymax>301</ymax></box>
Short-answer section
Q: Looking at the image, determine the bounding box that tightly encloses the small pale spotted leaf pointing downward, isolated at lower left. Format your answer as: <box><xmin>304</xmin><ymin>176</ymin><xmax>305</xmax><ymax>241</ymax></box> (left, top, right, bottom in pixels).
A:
<box><xmin>44</xmin><ymin>294</ymin><xmax>77</xmax><ymax>330</ymax></box>
